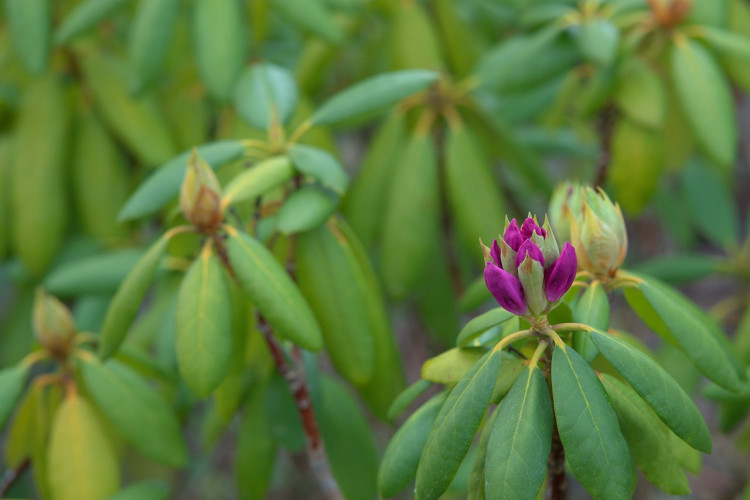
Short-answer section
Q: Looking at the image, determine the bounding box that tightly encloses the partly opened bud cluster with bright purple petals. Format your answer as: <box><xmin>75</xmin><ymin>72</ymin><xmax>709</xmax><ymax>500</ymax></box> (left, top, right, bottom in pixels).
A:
<box><xmin>482</xmin><ymin>217</ymin><xmax>578</xmax><ymax>317</ymax></box>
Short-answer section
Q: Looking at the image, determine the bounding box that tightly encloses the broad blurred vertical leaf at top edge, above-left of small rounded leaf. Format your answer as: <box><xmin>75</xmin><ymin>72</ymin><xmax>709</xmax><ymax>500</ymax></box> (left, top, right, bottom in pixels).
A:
<box><xmin>193</xmin><ymin>0</ymin><xmax>247</xmax><ymax>102</ymax></box>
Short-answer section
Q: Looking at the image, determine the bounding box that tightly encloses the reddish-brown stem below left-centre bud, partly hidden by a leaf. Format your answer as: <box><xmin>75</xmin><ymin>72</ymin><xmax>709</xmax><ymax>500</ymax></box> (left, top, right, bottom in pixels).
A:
<box><xmin>214</xmin><ymin>235</ymin><xmax>344</xmax><ymax>500</ymax></box>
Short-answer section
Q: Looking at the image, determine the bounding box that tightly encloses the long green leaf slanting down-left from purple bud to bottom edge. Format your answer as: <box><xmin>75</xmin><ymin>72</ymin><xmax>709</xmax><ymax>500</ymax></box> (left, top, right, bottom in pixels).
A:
<box><xmin>414</xmin><ymin>350</ymin><xmax>500</xmax><ymax>500</ymax></box>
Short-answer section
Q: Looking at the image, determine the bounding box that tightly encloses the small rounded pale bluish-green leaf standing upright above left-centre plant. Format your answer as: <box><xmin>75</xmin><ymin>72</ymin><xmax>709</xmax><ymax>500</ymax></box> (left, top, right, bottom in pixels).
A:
<box><xmin>234</xmin><ymin>63</ymin><xmax>299</xmax><ymax>130</ymax></box>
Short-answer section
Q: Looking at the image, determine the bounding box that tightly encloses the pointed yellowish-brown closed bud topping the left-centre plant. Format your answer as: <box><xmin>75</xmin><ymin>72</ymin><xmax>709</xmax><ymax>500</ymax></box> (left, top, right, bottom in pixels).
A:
<box><xmin>180</xmin><ymin>149</ymin><xmax>223</xmax><ymax>233</ymax></box>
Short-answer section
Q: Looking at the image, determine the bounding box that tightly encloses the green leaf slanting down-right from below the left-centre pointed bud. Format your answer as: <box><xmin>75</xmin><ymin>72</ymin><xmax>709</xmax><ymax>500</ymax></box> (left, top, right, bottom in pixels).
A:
<box><xmin>227</xmin><ymin>230</ymin><xmax>323</xmax><ymax>351</ymax></box>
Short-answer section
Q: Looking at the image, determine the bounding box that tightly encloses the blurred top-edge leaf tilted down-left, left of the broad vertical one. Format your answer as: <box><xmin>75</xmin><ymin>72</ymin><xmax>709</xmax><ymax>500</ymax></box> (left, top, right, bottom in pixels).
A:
<box><xmin>128</xmin><ymin>0</ymin><xmax>180</xmax><ymax>91</ymax></box>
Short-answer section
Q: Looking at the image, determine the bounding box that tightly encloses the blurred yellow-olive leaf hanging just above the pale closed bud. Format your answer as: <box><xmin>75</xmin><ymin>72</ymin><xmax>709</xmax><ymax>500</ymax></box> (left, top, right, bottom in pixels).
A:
<box><xmin>608</xmin><ymin>118</ymin><xmax>665</xmax><ymax>214</ymax></box>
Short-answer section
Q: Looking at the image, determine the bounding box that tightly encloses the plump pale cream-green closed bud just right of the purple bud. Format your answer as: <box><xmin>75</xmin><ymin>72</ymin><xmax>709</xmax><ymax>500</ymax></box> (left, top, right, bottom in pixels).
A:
<box><xmin>571</xmin><ymin>187</ymin><xmax>628</xmax><ymax>276</ymax></box>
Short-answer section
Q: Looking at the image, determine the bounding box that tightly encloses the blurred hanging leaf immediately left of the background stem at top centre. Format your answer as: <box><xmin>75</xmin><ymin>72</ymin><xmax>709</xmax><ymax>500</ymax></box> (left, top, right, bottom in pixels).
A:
<box><xmin>381</xmin><ymin>134</ymin><xmax>440</xmax><ymax>299</ymax></box>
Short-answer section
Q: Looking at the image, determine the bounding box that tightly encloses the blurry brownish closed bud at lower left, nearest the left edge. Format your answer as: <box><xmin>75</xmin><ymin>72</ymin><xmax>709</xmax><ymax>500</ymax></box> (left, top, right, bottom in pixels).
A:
<box><xmin>32</xmin><ymin>288</ymin><xmax>76</xmax><ymax>358</ymax></box>
